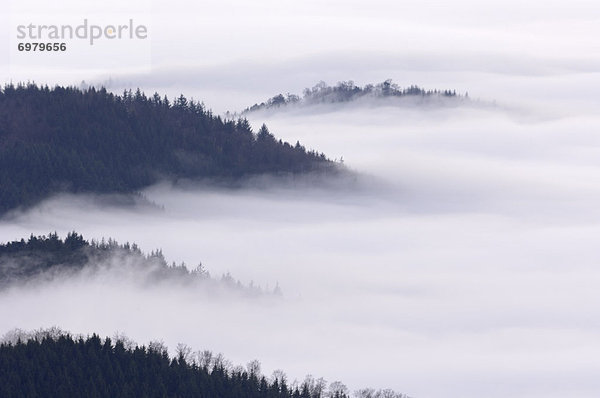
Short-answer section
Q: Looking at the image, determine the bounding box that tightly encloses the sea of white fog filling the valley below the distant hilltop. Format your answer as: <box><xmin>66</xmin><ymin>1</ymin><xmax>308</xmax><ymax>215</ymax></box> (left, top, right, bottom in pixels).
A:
<box><xmin>0</xmin><ymin>95</ymin><xmax>600</xmax><ymax>398</ymax></box>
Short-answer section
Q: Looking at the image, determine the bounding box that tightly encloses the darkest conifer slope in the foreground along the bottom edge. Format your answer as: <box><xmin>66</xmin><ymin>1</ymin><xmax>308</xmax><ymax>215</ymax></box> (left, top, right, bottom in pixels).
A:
<box><xmin>0</xmin><ymin>333</ymin><xmax>347</xmax><ymax>398</ymax></box>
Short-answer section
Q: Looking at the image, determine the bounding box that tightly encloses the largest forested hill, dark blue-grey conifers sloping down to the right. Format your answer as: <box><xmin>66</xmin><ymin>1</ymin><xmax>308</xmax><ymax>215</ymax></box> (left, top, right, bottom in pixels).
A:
<box><xmin>0</xmin><ymin>84</ymin><xmax>335</xmax><ymax>214</ymax></box>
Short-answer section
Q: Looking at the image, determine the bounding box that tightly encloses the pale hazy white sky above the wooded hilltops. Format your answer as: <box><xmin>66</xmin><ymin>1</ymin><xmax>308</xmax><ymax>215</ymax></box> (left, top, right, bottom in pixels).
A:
<box><xmin>0</xmin><ymin>0</ymin><xmax>600</xmax><ymax>112</ymax></box>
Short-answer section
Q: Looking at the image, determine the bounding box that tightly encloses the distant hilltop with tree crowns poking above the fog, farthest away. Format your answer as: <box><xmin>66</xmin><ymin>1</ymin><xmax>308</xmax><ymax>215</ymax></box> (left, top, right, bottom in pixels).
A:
<box><xmin>242</xmin><ymin>79</ymin><xmax>468</xmax><ymax>113</ymax></box>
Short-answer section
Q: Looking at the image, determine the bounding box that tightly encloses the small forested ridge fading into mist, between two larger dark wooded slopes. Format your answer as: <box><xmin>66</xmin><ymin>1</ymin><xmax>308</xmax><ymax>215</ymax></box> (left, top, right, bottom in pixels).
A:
<box><xmin>0</xmin><ymin>232</ymin><xmax>268</xmax><ymax>297</ymax></box>
